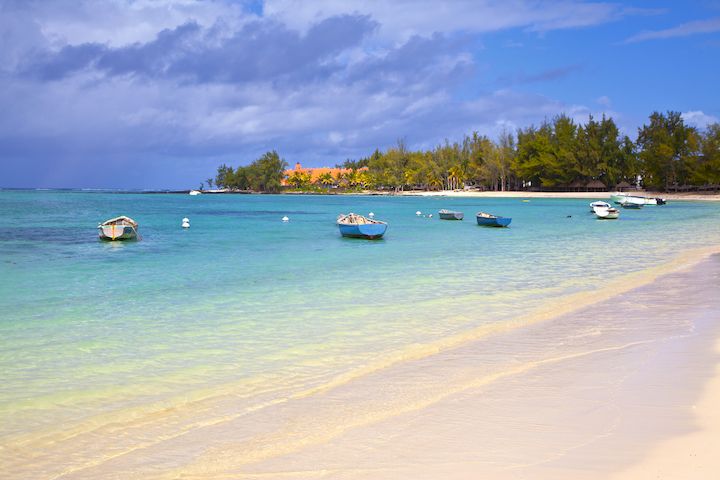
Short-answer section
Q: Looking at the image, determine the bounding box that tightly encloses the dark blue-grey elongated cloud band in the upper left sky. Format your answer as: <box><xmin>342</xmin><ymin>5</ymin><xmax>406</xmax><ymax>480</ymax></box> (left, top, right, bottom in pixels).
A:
<box><xmin>23</xmin><ymin>15</ymin><xmax>376</xmax><ymax>83</ymax></box>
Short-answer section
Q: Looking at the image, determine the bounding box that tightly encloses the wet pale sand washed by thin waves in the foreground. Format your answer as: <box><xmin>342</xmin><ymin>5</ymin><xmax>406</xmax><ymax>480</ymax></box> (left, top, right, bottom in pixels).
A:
<box><xmin>156</xmin><ymin>248</ymin><xmax>720</xmax><ymax>480</ymax></box>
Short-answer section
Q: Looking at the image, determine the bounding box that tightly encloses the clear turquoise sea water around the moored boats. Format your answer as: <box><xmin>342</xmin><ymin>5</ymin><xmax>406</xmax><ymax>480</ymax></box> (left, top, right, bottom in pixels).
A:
<box><xmin>0</xmin><ymin>191</ymin><xmax>720</xmax><ymax>470</ymax></box>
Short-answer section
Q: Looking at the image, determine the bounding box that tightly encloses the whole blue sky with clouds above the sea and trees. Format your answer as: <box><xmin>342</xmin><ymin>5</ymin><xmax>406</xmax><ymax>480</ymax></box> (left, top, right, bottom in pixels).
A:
<box><xmin>0</xmin><ymin>0</ymin><xmax>720</xmax><ymax>189</ymax></box>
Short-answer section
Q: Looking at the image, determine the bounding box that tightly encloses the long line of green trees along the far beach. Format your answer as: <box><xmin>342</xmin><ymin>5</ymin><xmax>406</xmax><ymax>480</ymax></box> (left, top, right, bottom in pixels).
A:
<box><xmin>208</xmin><ymin>111</ymin><xmax>720</xmax><ymax>191</ymax></box>
